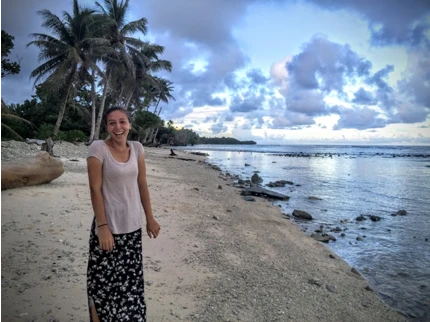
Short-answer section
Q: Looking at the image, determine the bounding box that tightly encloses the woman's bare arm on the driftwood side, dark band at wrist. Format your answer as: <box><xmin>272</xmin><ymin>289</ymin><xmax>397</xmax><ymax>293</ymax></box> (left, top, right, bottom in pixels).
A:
<box><xmin>87</xmin><ymin>157</ymin><xmax>114</xmax><ymax>250</ymax></box>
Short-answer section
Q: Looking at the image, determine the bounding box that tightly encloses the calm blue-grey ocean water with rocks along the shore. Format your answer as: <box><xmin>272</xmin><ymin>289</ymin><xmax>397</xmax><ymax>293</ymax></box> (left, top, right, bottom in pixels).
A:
<box><xmin>178</xmin><ymin>145</ymin><xmax>430</xmax><ymax>321</ymax></box>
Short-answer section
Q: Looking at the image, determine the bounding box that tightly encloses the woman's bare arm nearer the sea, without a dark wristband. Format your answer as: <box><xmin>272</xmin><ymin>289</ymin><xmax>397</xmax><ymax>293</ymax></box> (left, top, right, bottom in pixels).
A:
<box><xmin>137</xmin><ymin>155</ymin><xmax>160</xmax><ymax>238</ymax></box>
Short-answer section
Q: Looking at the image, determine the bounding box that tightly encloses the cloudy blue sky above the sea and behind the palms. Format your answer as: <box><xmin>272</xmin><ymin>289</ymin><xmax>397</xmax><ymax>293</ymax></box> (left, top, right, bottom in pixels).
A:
<box><xmin>0</xmin><ymin>0</ymin><xmax>430</xmax><ymax>145</ymax></box>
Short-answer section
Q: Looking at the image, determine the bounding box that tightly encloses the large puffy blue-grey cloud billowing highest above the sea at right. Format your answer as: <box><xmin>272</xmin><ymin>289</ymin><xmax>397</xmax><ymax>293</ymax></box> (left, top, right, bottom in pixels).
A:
<box><xmin>287</xmin><ymin>36</ymin><xmax>371</xmax><ymax>93</ymax></box>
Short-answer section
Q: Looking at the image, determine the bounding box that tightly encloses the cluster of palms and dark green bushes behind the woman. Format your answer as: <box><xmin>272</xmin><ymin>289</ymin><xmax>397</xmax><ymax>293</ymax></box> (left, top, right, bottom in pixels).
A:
<box><xmin>0</xmin><ymin>0</ymin><xmax>202</xmax><ymax>145</ymax></box>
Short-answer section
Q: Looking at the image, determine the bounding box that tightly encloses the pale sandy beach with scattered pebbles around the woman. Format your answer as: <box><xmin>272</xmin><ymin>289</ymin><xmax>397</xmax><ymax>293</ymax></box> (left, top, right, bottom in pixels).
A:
<box><xmin>0</xmin><ymin>143</ymin><xmax>406</xmax><ymax>322</ymax></box>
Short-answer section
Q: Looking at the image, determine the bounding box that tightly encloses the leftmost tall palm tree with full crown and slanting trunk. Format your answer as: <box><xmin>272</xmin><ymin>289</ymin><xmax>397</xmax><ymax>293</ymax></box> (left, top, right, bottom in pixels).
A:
<box><xmin>27</xmin><ymin>0</ymin><xmax>95</xmax><ymax>137</ymax></box>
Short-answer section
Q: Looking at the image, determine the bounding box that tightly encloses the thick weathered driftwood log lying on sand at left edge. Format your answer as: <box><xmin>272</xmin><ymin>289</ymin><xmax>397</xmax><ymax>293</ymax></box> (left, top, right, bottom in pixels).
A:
<box><xmin>0</xmin><ymin>152</ymin><xmax>64</xmax><ymax>190</ymax></box>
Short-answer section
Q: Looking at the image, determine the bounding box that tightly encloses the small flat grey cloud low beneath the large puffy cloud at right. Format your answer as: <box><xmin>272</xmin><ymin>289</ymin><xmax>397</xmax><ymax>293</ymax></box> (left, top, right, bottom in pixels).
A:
<box><xmin>332</xmin><ymin>106</ymin><xmax>387</xmax><ymax>130</ymax></box>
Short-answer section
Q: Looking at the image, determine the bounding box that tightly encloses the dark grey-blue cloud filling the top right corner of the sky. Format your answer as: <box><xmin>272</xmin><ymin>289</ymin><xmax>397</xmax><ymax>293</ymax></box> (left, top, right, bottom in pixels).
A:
<box><xmin>309</xmin><ymin>0</ymin><xmax>430</xmax><ymax>45</ymax></box>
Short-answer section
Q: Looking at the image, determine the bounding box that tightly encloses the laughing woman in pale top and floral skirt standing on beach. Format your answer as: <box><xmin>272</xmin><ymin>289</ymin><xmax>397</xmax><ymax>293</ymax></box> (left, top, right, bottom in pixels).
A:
<box><xmin>87</xmin><ymin>107</ymin><xmax>160</xmax><ymax>322</ymax></box>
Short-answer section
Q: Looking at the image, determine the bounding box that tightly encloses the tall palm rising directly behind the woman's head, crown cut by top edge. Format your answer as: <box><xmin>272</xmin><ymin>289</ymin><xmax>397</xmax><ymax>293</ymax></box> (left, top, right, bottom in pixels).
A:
<box><xmin>94</xmin><ymin>0</ymin><xmax>147</xmax><ymax>139</ymax></box>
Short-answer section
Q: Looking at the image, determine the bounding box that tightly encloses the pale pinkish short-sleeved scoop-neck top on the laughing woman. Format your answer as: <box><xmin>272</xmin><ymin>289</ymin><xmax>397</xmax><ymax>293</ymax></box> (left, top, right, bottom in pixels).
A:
<box><xmin>87</xmin><ymin>140</ymin><xmax>144</xmax><ymax>234</ymax></box>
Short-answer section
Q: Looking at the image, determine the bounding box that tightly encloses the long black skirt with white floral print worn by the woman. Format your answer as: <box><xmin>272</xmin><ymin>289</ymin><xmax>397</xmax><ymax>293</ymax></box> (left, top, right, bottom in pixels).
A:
<box><xmin>87</xmin><ymin>221</ymin><xmax>146</xmax><ymax>322</ymax></box>
